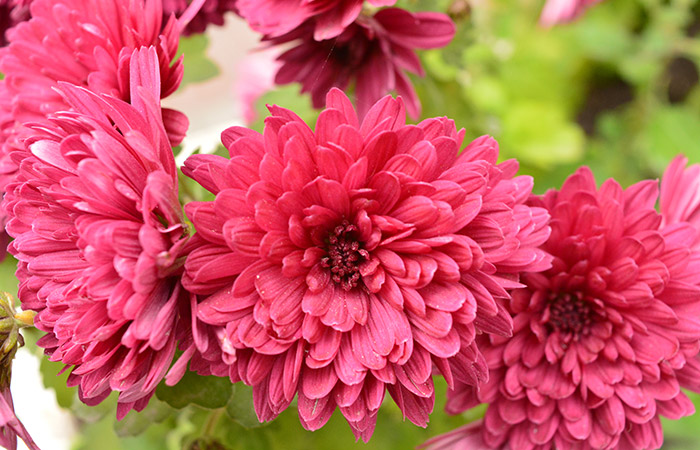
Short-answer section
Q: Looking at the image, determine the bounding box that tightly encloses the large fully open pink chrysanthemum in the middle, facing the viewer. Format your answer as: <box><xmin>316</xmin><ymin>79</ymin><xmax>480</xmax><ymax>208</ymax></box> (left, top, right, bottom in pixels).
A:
<box><xmin>183</xmin><ymin>89</ymin><xmax>549</xmax><ymax>441</ymax></box>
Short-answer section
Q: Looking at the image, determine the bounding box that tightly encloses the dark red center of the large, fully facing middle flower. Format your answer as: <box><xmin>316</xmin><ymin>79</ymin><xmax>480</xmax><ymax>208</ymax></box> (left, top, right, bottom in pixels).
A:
<box><xmin>321</xmin><ymin>220</ymin><xmax>369</xmax><ymax>291</ymax></box>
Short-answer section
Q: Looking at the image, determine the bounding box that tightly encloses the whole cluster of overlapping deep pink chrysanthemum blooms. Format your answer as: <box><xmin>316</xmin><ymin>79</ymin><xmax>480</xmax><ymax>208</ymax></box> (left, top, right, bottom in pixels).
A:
<box><xmin>0</xmin><ymin>0</ymin><xmax>700</xmax><ymax>449</ymax></box>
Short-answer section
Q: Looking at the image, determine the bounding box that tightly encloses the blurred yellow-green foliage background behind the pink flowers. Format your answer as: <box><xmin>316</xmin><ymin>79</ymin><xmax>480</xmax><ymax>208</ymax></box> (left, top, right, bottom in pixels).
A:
<box><xmin>10</xmin><ymin>0</ymin><xmax>700</xmax><ymax>450</ymax></box>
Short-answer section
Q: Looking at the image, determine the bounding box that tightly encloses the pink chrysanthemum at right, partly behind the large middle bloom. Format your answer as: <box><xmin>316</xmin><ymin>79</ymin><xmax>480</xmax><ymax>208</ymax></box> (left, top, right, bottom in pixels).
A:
<box><xmin>428</xmin><ymin>168</ymin><xmax>700</xmax><ymax>450</ymax></box>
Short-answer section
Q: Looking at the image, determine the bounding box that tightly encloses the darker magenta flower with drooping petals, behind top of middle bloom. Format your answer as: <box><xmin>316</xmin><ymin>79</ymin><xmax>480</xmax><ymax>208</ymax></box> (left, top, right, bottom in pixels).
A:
<box><xmin>270</xmin><ymin>8</ymin><xmax>455</xmax><ymax>119</ymax></box>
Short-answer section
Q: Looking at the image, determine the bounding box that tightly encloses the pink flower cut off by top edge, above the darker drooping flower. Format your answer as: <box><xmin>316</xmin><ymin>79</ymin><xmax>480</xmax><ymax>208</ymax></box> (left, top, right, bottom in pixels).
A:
<box><xmin>237</xmin><ymin>0</ymin><xmax>396</xmax><ymax>41</ymax></box>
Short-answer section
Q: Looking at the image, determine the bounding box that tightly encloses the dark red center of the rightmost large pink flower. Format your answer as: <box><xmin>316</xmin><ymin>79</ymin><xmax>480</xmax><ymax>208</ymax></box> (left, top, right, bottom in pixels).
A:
<box><xmin>547</xmin><ymin>292</ymin><xmax>593</xmax><ymax>338</ymax></box>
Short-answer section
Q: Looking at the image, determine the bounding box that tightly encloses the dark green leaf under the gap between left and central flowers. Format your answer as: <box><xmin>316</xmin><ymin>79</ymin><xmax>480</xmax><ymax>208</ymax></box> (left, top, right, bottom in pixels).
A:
<box><xmin>156</xmin><ymin>371</ymin><xmax>233</xmax><ymax>409</ymax></box>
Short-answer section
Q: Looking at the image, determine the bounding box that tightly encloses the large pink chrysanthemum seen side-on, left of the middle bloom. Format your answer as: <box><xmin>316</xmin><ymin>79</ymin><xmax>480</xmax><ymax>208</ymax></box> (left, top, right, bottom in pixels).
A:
<box><xmin>5</xmin><ymin>47</ymin><xmax>191</xmax><ymax>418</ymax></box>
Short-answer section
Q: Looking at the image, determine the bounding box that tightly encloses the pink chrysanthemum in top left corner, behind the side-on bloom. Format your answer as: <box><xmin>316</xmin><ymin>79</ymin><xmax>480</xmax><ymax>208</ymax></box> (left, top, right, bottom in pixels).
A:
<box><xmin>0</xmin><ymin>0</ymin><xmax>187</xmax><ymax>149</ymax></box>
